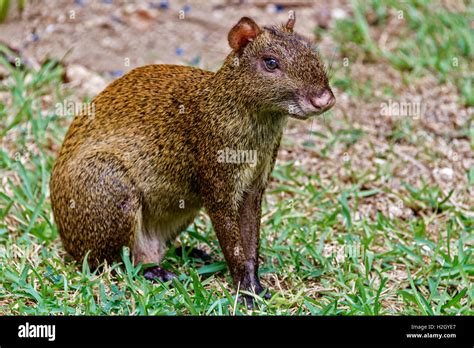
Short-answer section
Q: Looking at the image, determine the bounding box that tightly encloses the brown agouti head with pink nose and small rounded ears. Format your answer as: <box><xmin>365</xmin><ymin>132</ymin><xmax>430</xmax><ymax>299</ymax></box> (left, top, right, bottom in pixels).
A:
<box><xmin>228</xmin><ymin>15</ymin><xmax>336</xmax><ymax>119</ymax></box>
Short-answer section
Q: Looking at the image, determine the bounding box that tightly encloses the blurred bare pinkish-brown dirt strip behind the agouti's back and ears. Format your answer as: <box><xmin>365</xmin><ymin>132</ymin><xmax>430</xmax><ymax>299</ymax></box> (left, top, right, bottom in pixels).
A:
<box><xmin>0</xmin><ymin>0</ymin><xmax>338</xmax><ymax>75</ymax></box>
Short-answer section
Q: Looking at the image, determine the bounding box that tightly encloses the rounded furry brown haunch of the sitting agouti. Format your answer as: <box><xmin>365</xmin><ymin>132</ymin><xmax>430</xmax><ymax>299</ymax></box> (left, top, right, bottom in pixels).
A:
<box><xmin>51</xmin><ymin>152</ymin><xmax>140</xmax><ymax>268</ymax></box>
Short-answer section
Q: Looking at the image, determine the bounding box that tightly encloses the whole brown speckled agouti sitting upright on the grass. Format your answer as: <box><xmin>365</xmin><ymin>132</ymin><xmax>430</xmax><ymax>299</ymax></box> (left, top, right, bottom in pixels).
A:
<box><xmin>50</xmin><ymin>15</ymin><xmax>335</xmax><ymax>302</ymax></box>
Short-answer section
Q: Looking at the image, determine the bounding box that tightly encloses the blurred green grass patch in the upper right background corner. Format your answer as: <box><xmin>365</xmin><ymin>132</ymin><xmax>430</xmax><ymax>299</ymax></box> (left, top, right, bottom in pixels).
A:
<box><xmin>332</xmin><ymin>0</ymin><xmax>474</xmax><ymax>106</ymax></box>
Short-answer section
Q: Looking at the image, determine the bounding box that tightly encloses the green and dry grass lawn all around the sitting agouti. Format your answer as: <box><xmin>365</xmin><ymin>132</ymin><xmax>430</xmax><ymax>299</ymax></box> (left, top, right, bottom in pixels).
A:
<box><xmin>0</xmin><ymin>1</ymin><xmax>474</xmax><ymax>315</ymax></box>
